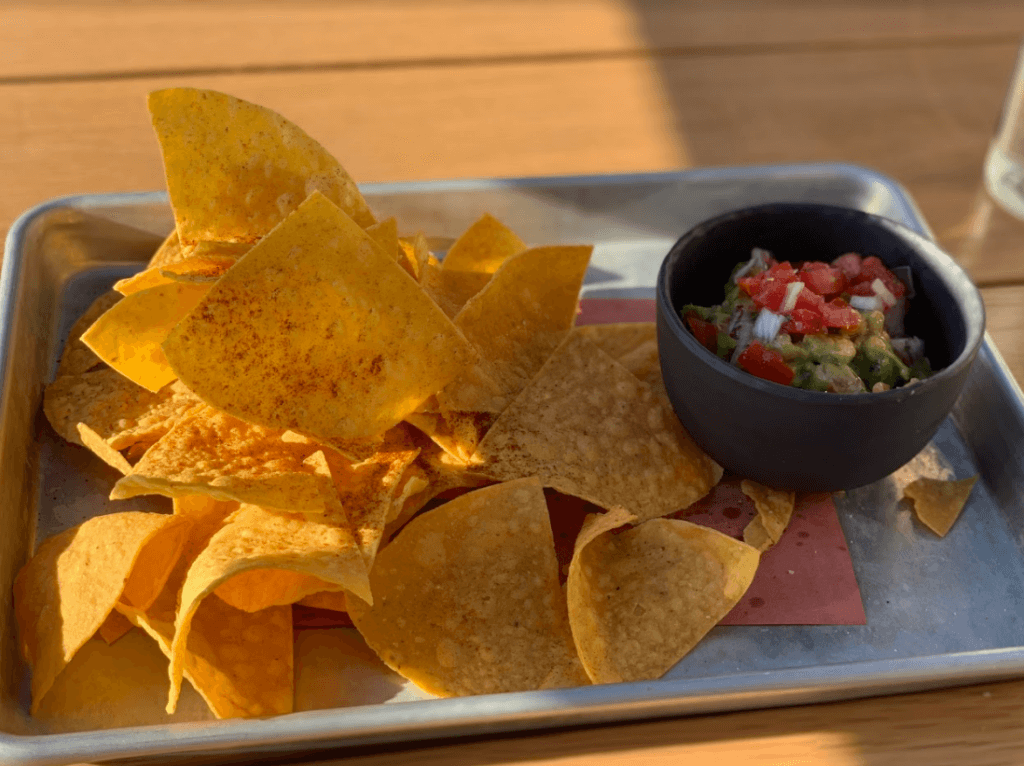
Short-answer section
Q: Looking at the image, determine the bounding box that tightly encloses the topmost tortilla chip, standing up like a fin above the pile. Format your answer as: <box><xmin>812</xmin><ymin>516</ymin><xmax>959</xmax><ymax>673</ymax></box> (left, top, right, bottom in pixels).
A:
<box><xmin>148</xmin><ymin>88</ymin><xmax>375</xmax><ymax>245</ymax></box>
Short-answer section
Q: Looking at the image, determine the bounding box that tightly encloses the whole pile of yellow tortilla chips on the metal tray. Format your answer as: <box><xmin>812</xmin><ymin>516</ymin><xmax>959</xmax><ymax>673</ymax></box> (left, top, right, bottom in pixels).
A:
<box><xmin>14</xmin><ymin>89</ymin><xmax>770</xmax><ymax>718</ymax></box>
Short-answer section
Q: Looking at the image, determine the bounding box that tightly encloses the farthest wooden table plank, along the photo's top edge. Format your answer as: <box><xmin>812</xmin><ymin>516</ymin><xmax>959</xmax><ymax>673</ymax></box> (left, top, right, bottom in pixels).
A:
<box><xmin>6</xmin><ymin>0</ymin><xmax>1024</xmax><ymax>82</ymax></box>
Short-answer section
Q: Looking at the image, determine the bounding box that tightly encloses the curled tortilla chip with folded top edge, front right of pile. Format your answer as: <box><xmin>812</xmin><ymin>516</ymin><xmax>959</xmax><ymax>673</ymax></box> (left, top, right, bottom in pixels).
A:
<box><xmin>566</xmin><ymin>510</ymin><xmax>761</xmax><ymax>683</ymax></box>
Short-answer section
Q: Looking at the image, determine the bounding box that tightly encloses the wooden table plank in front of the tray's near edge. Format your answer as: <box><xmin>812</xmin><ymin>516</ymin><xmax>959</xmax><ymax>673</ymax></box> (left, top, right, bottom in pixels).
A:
<box><xmin>264</xmin><ymin>682</ymin><xmax>1024</xmax><ymax>766</ymax></box>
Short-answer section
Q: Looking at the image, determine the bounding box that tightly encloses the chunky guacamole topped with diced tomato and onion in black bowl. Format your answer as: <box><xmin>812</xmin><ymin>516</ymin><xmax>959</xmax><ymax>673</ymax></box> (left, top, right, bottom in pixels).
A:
<box><xmin>680</xmin><ymin>248</ymin><xmax>932</xmax><ymax>393</ymax></box>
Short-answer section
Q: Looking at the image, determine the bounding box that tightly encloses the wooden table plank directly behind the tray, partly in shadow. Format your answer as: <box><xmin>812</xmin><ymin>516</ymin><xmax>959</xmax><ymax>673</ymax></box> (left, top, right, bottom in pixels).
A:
<box><xmin>0</xmin><ymin>45</ymin><xmax>1024</xmax><ymax>284</ymax></box>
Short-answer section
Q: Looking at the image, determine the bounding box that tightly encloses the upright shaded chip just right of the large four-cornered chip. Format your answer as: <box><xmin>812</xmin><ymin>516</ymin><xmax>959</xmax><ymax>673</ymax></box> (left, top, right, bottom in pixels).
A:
<box><xmin>437</xmin><ymin>246</ymin><xmax>593</xmax><ymax>413</ymax></box>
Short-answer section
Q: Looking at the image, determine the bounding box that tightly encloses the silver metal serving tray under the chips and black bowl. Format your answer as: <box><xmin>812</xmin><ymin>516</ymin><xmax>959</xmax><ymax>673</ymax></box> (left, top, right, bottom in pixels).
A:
<box><xmin>0</xmin><ymin>164</ymin><xmax>1024</xmax><ymax>764</ymax></box>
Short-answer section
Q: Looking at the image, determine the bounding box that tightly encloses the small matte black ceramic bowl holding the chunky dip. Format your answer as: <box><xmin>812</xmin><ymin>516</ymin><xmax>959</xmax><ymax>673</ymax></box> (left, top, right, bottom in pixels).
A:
<box><xmin>657</xmin><ymin>204</ymin><xmax>985</xmax><ymax>492</ymax></box>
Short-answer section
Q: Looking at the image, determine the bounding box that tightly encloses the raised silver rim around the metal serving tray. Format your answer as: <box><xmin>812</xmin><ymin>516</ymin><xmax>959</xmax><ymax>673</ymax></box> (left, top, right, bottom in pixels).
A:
<box><xmin>0</xmin><ymin>158</ymin><xmax>1024</xmax><ymax>766</ymax></box>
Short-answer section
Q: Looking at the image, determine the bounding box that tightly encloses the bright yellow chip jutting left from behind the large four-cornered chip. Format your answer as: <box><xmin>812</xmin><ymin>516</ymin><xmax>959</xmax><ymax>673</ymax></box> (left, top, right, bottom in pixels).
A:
<box><xmin>82</xmin><ymin>283</ymin><xmax>210</xmax><ymax>393</ymax></box>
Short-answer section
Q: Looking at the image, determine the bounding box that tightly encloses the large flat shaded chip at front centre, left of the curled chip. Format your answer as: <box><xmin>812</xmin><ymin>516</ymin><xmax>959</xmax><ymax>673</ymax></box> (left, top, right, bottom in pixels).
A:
<box><xmin>347</xmin><ymin>479</ymin><xmax>586</xmax><ymax>696</ymax></box>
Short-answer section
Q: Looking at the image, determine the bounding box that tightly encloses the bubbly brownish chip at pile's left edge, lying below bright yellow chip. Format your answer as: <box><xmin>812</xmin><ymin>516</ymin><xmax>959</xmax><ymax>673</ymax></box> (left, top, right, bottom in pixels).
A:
<box><xmin>43</xmin><ymin>368</ymin><xmax>202</xmax><ymax>451</ymax></box>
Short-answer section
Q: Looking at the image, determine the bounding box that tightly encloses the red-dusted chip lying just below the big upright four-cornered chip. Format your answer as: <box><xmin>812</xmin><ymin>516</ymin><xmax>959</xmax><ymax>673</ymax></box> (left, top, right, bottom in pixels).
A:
<box><xmin>111</xmin><ymin>407</ymin><xmax>333</xmax><ymax>513</ymax></box>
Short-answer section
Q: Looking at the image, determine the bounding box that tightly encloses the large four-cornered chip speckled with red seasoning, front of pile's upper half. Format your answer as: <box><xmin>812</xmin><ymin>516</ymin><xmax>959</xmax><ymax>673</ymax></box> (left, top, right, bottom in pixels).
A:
<box><xmin>164</xmin><ymin>194</ymin><xmax>473</xmax><ymax>439</ymax></box>
